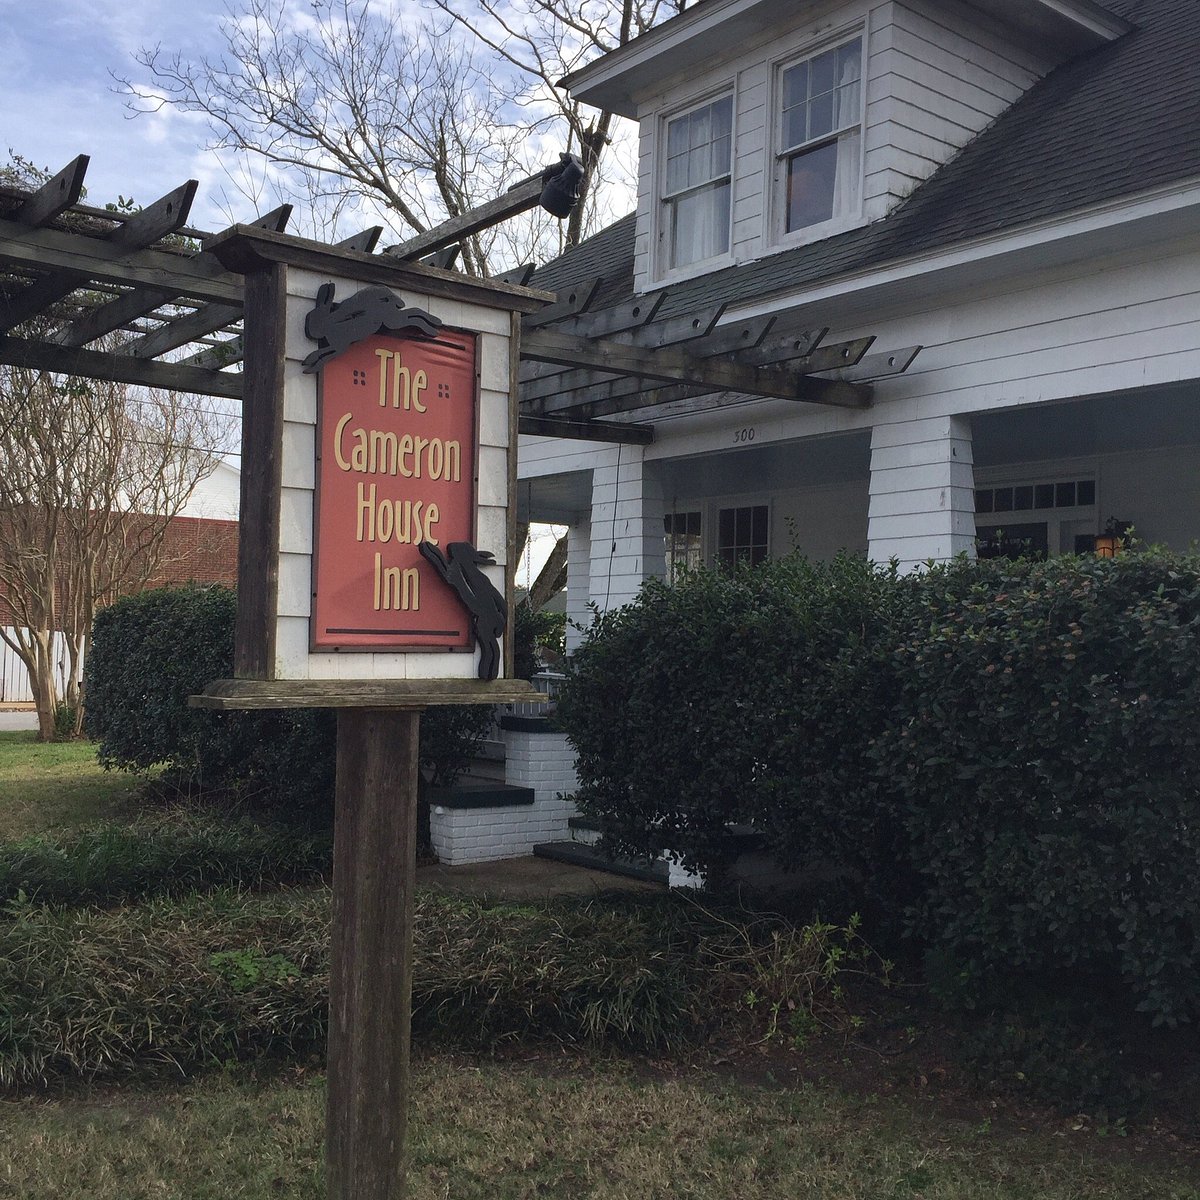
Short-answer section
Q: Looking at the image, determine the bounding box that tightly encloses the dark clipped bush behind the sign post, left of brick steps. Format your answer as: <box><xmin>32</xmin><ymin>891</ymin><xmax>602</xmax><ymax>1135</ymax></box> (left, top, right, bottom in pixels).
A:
<box><xmin>86</xmin><ymin>587</ymin><xmax>491</xmax><ymax>818</ymax></box>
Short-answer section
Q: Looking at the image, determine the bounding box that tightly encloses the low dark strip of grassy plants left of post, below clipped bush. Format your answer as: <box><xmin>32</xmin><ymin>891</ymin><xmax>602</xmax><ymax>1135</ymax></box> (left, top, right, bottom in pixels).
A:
<box><xmin>0</xmin><ymin>814</ymin><xmax>332</xmax><ymax>905</ymax></box>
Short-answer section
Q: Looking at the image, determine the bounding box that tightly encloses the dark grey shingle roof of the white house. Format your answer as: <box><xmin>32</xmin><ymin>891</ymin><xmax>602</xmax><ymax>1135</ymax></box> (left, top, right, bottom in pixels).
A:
<box><xmin>533</xmin><ymin>0</ymin><xmax>1200</xmax><ymax>316</ymax></box>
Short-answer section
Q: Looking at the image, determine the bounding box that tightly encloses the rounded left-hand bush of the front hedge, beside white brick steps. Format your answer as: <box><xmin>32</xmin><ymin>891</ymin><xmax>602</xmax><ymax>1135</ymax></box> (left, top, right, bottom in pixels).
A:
<box><xmin>559</xmin><ymin>557</ymin><xmax>911</xmax><ymax>907</ymax></box>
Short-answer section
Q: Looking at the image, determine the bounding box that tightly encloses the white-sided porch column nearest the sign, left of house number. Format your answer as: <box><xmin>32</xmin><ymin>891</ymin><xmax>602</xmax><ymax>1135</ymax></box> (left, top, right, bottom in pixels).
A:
<box><xmin>588</xmin><ymin>445</ymin><xmax>666</xmax><ymax>612</ymax></box>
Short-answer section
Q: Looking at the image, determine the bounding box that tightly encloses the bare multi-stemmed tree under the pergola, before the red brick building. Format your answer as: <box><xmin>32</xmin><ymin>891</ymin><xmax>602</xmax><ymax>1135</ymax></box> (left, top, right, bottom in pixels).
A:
<box><xmin>0</xmin><ymin>350</ymin><xmax>228</xmax><ymax>740</ymax></box>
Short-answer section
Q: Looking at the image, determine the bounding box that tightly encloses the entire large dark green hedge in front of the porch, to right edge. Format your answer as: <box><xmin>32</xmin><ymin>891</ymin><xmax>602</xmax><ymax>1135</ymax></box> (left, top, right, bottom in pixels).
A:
<box><xmin>559</xmin><ymin>551</ymin><xmax>1200</xmax><ymax>1024</ymax></box>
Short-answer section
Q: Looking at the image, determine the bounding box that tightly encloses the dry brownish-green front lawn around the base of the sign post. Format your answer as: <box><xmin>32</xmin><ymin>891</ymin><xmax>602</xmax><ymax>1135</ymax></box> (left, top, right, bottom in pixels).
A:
<box><xmin>0</xmin><ymin>1057</ymin><xmax>1200</xmax><ymax>1200</ymax></box>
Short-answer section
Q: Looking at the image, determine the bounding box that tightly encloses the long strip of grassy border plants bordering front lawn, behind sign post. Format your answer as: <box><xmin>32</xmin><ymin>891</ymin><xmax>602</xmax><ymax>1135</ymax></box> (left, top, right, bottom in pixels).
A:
<box><xmin>0</xmin><ymin>888</ymin><xmax>872</xmax><ymax>1086</ymax></box>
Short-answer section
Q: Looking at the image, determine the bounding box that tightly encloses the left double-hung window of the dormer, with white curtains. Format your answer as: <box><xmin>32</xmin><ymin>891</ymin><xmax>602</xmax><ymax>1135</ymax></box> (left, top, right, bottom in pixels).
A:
<box><xmin>662</xmin><ymin>95</ymin><xmax>733</xmax><ymax>270</ymax></box>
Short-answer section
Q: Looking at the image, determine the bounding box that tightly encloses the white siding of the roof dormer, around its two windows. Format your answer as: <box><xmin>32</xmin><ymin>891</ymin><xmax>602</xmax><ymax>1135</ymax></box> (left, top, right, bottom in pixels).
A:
<box><xmin>634</xmin><ymin>0</ymin><xmax>1054</xmax><ymax>290</ymax></box>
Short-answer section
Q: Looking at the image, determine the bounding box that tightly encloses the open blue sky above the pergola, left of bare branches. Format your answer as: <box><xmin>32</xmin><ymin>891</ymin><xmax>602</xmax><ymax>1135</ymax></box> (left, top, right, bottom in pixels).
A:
<box><xmin>0</xmin><ymin>0</ymin><xmax>248</xmax><ymax>228</ymax></box>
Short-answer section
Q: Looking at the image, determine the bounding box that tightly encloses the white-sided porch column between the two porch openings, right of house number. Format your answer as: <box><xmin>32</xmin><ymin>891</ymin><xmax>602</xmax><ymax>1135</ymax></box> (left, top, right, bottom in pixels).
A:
<box><xmin>868</xmin><ymin>416</ymin><xmax>976</xmax><ymax>571</ymax></box>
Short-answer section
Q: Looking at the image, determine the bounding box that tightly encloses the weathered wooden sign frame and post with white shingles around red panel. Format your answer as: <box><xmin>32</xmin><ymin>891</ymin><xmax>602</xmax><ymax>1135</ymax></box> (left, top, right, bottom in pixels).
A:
<box><xmin>191</xmin><ymin>226</ymin><xmax>553</xmax><ymax>1200</ymax></box>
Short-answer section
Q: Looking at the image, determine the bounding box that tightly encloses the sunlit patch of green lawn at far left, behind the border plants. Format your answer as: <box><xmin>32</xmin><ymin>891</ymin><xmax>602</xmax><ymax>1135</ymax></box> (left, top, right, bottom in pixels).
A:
<box><xmin>0</xmin><ymin>731</ymin><xmax>142</xmax><ymax>841</ymax></box>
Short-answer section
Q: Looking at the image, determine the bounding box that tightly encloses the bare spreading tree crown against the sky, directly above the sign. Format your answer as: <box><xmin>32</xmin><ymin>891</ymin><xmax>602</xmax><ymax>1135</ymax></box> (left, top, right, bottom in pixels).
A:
<box><xmin>120</xmin><ymin>0</ymin><xmax>522</xmax><ymax>275</ymax></box>
